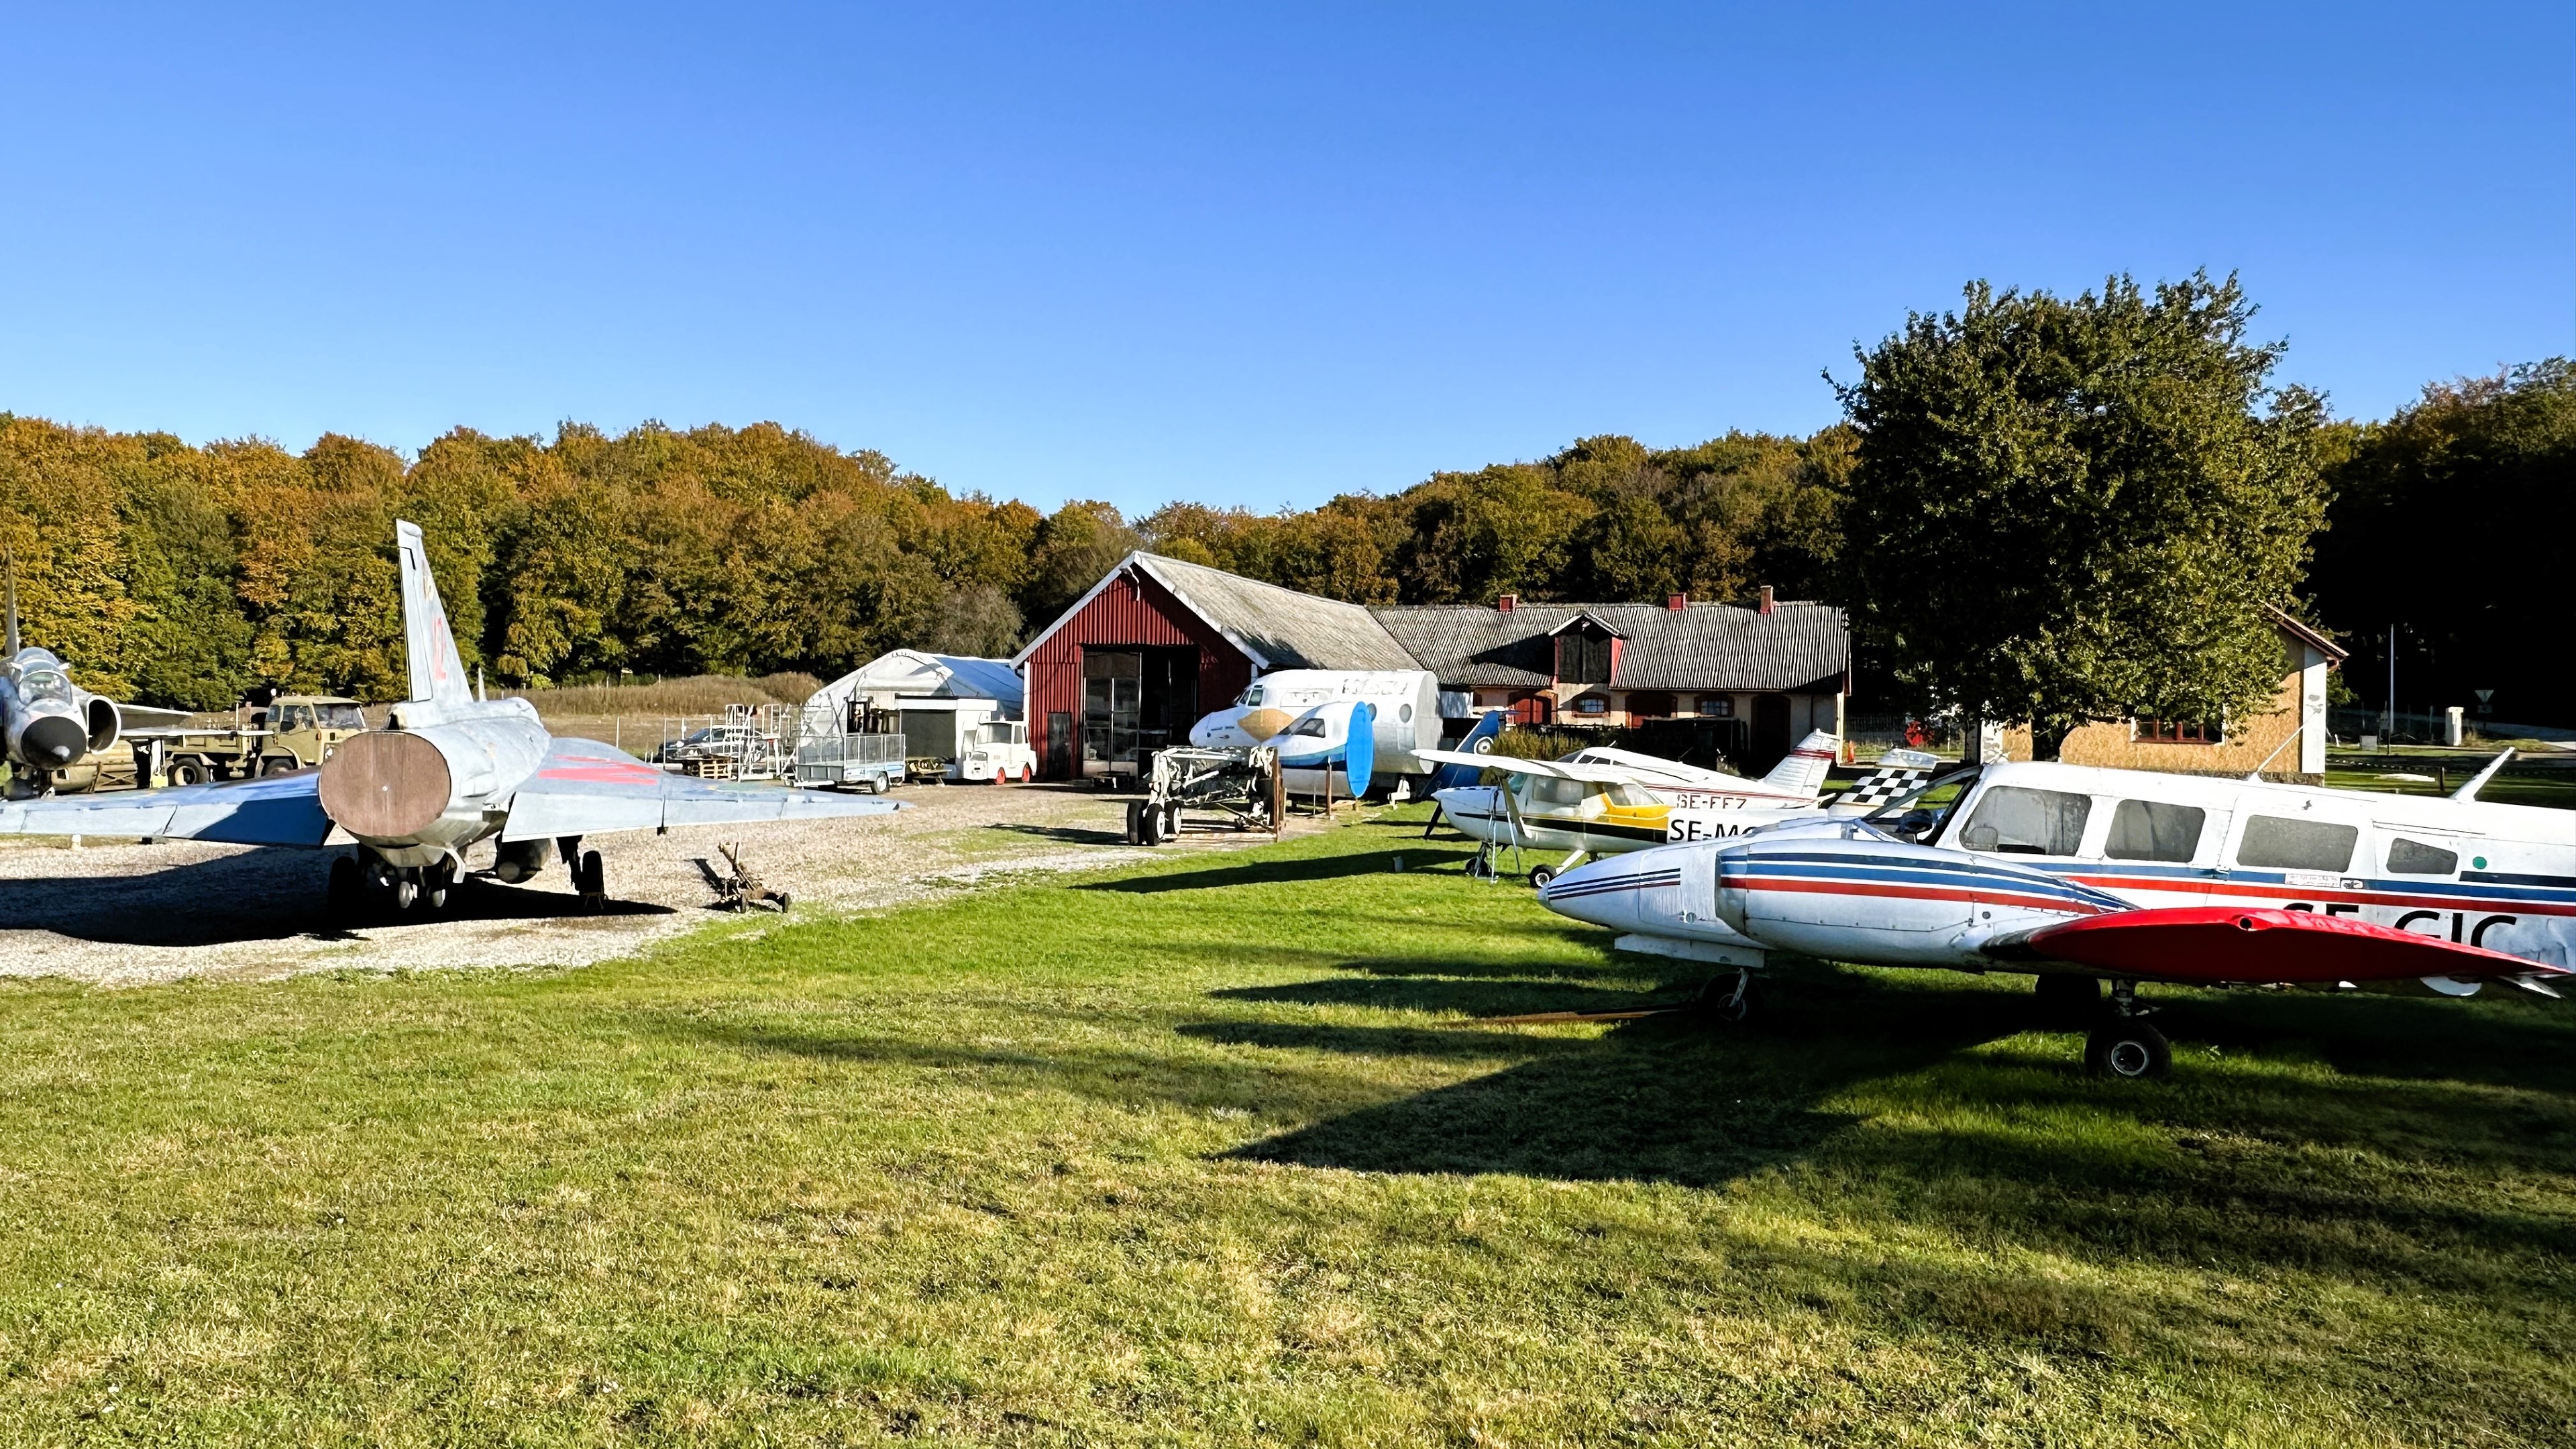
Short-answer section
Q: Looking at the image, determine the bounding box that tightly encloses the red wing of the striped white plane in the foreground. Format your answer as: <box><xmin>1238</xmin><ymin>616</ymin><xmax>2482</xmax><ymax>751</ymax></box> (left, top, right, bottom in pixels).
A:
<box><xmin>2025</xmin><ymin>905</ymin><xmax>2568</xmax><ymax>985</ymax></box>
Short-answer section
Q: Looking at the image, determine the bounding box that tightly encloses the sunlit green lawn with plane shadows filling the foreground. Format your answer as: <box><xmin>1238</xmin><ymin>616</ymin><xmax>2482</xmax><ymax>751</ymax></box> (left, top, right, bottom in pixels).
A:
<box><xmin>0</xmin><ymin>804</ymin><xmax>2576</xmax><ymax>1446</ymax></box>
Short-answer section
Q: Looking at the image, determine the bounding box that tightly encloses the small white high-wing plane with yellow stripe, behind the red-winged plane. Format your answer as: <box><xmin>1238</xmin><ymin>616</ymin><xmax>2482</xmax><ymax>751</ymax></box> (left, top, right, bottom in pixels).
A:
<box><xmin>1422</xmin><ymin>730</ymin><xmax>1875</xmax><ymax>887</ymax></box>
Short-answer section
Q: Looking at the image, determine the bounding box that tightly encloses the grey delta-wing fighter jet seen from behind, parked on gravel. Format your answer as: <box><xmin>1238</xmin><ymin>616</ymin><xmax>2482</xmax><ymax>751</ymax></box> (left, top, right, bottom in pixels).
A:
<box><xmin>0</xmin><ymin>523</ymin><xmax>896</xmax><ymax>913</ymax></box>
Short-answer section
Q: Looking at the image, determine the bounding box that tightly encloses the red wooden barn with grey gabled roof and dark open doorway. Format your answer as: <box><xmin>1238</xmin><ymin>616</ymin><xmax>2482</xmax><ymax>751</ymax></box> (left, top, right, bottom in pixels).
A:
<box><xmin>1010</xmin><ymin>551</ymin><xmax>1419</xmax><ymax>779</ymax></box>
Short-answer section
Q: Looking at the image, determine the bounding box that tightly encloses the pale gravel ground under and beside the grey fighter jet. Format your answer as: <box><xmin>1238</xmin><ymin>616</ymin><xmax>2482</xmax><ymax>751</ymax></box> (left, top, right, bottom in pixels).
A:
<box><xmin>0</xmin><ymin>786</ymin><xmax>1296</xmax><ymax>985</ymax></box>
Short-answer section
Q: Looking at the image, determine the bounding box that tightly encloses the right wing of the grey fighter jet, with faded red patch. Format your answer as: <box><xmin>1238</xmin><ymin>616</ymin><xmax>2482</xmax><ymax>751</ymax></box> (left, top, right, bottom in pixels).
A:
<box><xmin>500</xmin><ymin>740</ymin><xmax>902</xmax><ymax>841</ymax></box>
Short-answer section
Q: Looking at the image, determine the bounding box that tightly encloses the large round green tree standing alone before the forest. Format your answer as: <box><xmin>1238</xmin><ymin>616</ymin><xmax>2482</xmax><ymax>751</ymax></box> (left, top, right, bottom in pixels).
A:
<box><xmin>1839</xmin><ymin>273</ymin><xmax>2326</xmax><ymax>758</ymax></box>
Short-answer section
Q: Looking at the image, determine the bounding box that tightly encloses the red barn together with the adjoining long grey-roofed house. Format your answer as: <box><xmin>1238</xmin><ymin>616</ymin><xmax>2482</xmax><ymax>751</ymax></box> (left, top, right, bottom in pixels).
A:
<box><xmin>1012</xmin><ymin>551</ymin><xmax>1852</xmax><ymax>779</ymax></box>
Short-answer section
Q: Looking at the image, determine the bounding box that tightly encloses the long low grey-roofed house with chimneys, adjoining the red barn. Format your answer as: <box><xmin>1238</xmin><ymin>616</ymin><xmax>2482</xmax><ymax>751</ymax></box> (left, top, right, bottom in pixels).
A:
<box><xmin>1371</xmin><ymin>588</ymin><xmax>1852</xmax><ymax>771</ymax></box>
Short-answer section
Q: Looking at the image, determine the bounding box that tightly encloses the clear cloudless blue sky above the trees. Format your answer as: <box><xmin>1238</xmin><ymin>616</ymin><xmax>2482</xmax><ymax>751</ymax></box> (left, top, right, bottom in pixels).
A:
<box><xmin>0</xmin><ymin>0</ymin><xmax>2576</xmax><ymax>511</ymax></box>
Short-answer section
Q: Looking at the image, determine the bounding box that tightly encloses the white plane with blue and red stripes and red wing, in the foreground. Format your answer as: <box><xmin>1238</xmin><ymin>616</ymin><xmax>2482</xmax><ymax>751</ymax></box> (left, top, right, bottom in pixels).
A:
<box><xmin>1543</xmin><ymin>750</ymin><xmax>2576</xmax><ymax>1078</ymax></box>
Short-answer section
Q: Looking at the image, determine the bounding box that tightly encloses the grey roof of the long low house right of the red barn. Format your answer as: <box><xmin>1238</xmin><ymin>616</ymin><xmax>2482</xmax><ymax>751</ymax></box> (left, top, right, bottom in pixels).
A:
<box><xmin>1371</xmin><ymin>603</ymin><xmax>1852</xmax><ymax>691</ymax></box>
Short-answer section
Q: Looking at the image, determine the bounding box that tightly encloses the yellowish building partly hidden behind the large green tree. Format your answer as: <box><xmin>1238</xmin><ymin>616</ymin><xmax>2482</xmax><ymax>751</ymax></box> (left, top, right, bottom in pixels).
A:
<box><xmin>2004</xmin><ymin>608</ymin><xmax>2347</xmax><ymax>779</ymax></box>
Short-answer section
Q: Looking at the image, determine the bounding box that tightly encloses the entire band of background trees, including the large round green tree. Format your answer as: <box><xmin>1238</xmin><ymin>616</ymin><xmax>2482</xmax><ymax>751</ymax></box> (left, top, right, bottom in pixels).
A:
<box><xmin>0</xmin><ymin>276</ymin><xmax>2576</xmax><ymax>735</ymax></box>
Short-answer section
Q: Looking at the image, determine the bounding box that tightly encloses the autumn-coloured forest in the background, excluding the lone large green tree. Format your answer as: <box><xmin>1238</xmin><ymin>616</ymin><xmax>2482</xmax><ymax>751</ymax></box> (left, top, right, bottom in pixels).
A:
<box><xmin>0</xmin><ymin>358</ymin><xmax>2576</xmax><ymax>709</ymax></box>
